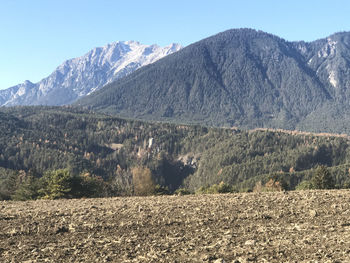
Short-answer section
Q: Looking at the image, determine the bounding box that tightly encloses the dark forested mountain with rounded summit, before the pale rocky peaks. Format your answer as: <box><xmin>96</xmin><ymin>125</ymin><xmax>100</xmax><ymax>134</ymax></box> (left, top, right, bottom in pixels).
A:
<box><xmin>76</xmin><ymin>29</ymin><xmax>350</xmax><ymax>132</ymax></box>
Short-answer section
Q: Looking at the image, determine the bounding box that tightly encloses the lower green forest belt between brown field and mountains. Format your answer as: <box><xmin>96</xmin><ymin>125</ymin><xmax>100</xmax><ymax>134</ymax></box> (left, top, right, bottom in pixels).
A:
<box><xmin>0</xmin><ymin>106</ymin><xmax>350</xmax><ymax>200</ymax></box>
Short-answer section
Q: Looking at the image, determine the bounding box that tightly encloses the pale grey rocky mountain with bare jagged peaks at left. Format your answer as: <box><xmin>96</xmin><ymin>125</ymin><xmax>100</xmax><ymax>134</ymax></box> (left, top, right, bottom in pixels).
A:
<box><xmin>0</xmin><ymin>41</ymin><xmax>181</xmax><ymax>106</ymax></box>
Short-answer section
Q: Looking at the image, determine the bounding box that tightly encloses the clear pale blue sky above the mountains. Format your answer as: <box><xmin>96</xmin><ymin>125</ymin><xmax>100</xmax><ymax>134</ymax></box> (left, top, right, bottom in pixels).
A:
<box><xmin>0</xmin><ymin>0</ymin><xmax>350</xmax><ymax>89</ymax></box>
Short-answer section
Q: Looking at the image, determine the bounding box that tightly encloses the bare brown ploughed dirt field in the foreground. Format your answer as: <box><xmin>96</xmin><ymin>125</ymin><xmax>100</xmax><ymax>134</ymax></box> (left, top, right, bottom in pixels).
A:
<box><xmin>0</xmin><ymin>191</ymin><xmax>350</xmax><ymax>263</ymax></box>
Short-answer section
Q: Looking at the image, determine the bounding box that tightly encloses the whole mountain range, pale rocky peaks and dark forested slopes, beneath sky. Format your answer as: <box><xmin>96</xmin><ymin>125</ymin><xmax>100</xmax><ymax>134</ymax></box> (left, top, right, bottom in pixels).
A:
<box><xmin>0</xmin><ymin>29</ymin><xmax>350</xmax><ymax>134</ymax></box>
